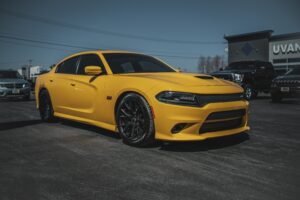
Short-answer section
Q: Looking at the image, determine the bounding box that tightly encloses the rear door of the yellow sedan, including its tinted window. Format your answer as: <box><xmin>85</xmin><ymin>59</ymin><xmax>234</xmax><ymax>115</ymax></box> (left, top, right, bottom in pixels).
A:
<box><xmin>49</xmin><ymin>56</ymin><xmax>79</xmax><ymax>114</ymax></box>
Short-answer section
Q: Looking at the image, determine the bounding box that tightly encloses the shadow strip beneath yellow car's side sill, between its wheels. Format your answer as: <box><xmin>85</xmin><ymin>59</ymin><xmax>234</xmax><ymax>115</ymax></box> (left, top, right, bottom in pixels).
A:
<box><xmin>59</xmin><ymin>119</ymin><xmax>121</xmax><ymax>139</ymax></box>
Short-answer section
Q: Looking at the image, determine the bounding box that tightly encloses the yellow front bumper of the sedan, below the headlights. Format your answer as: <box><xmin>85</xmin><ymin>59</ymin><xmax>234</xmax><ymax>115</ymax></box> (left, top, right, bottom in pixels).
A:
<box><xmin>153</xmin><ymin>101</ymin><xmax>250</xmax><ymax>141</ymax></box>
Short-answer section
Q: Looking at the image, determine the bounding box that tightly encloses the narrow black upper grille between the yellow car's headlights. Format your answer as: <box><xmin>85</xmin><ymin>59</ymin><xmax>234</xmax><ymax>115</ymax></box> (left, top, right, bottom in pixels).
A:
<box><xmin>197</xmin><ymin>93</ymin><xmax>244</xmax><ymax>106</ymax></box>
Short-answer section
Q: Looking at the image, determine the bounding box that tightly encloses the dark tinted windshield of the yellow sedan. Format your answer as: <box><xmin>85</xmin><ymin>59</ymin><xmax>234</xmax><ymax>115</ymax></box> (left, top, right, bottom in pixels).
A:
<box><xmin>103</xmin><ymin>53</ymin><xmax>175</xmax><ymax>74</ymax></box>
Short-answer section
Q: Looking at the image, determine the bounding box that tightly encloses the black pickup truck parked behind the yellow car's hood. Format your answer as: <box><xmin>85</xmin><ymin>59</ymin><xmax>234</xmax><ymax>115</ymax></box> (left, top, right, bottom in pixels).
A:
<box><xmin>211</xmin><ymin>61</ymin><xmax>276</xmax><ymax>100</ymax></box>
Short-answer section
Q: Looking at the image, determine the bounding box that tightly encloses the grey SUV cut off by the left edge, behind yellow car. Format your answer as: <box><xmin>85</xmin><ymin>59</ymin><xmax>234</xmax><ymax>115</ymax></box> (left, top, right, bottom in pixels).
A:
<box><xmin>0</xmin><ymin>70</ymin><xmax>30</xmax><ymax>100</ymax></box>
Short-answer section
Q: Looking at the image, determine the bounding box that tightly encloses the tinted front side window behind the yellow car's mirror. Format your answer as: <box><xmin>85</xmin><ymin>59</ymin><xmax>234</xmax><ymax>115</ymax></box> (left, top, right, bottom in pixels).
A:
<box><xmin>77</xmin><ymin>54</ymin><xmax>105</xmax><ymax>75</ymax></box>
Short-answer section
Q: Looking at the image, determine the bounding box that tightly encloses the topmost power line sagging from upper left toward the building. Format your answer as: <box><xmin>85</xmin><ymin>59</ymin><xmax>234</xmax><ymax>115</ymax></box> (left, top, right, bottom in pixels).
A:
<box><xmin>0</xmin><ymin>8</ymin><xmax>224</xmax><ymax>45</ymax></box>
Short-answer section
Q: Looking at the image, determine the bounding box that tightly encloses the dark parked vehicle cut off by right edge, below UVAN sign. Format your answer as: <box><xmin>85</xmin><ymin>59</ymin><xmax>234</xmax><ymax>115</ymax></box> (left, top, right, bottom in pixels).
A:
<box><xmin>271</xmin><ymin>68</ymin><xmax>300</xmax><ymax>102</ymax></box>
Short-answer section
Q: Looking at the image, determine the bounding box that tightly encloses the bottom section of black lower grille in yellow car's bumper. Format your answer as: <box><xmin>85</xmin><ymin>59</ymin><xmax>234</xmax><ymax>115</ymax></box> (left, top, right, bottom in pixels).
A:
<box><xmin>199</xmin><ymin>117</ymin><xmax>244</xmax><ymax>134</ymax></box>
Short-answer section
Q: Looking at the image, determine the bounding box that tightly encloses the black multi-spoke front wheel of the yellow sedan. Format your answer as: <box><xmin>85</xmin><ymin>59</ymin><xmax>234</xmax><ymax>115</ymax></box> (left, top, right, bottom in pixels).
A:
<box><xmin>116</xmin><ymin>93</ymin><xmax>154</xmax><ymax>146</ymax></box>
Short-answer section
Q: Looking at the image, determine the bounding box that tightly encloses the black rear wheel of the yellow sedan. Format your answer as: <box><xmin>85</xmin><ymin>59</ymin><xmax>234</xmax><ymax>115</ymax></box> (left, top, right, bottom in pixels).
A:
<box><xmin>39</xmin><ymin>90</ymin><xmax>55</xmax><ymax>122</ymax></box>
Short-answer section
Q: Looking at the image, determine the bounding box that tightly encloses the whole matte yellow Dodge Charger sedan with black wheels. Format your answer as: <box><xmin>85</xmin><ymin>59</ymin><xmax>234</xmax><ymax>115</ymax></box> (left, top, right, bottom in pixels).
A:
<box><xmin>35</xmin><ymin>51</ymin><xmax>249</xmax><ymax>146</ymax></box>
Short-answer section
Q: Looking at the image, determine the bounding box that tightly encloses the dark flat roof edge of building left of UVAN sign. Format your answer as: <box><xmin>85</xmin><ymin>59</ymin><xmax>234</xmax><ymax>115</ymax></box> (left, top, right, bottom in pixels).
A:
<box><xmin>224</xmin><ymin>30</ymin><xmax>274</xmax><ymax>42</ymax></box>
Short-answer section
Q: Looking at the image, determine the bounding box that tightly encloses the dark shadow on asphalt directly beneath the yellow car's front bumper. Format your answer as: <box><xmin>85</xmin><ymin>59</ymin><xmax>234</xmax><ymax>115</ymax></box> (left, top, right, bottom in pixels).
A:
<box><xmin>160</xmin><ymin>132</ymin><xmax>250</xmax><ymax>152</ymax></box>
